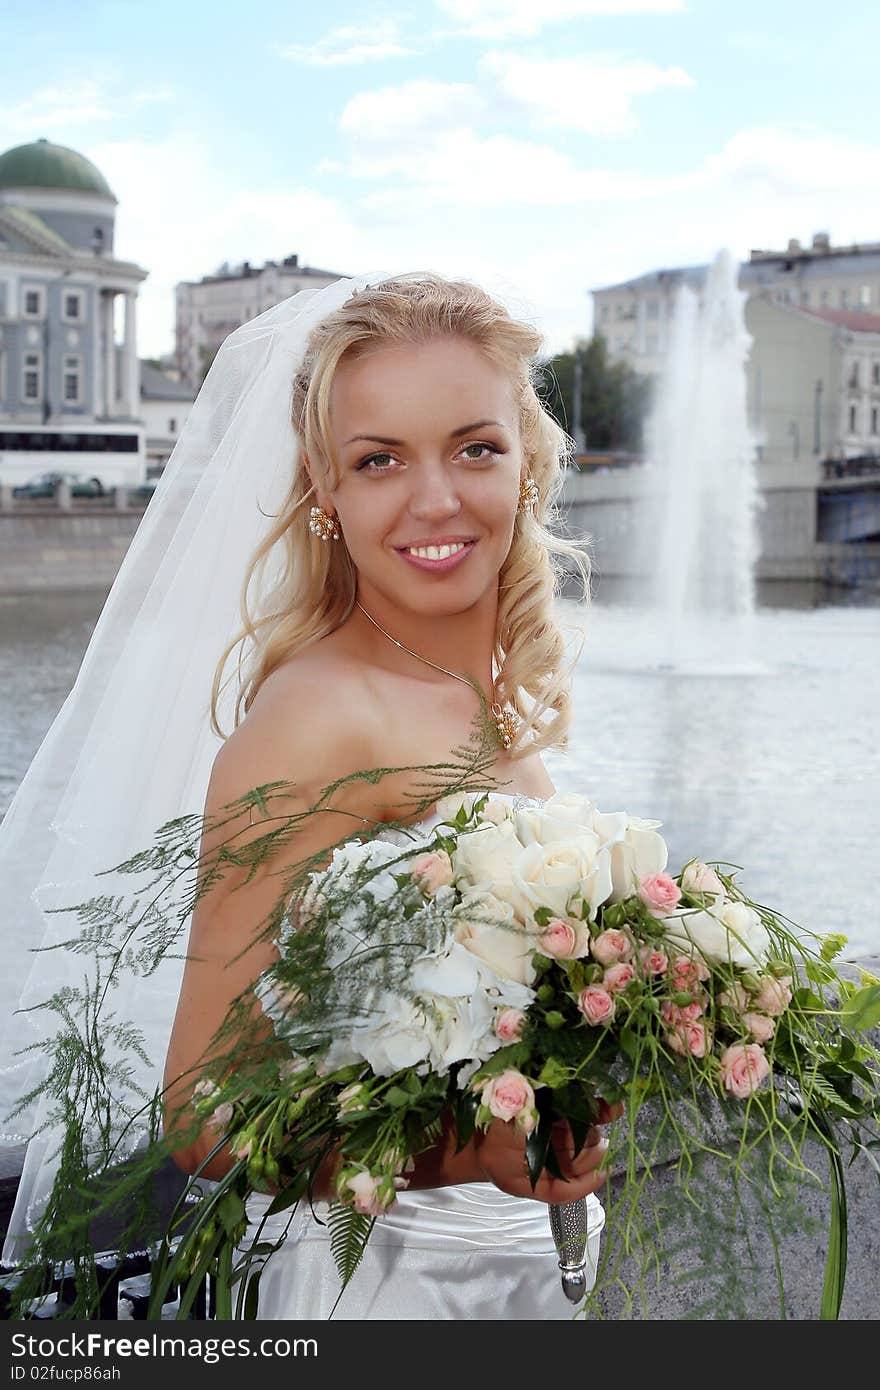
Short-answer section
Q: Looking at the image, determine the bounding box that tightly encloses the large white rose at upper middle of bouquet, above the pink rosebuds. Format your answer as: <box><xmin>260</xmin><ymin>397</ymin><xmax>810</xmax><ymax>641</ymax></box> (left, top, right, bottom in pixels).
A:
<box><xmin>494</xmin><ymin>831</ymin><xmax>612</xmax><ymax>924</ymax></box>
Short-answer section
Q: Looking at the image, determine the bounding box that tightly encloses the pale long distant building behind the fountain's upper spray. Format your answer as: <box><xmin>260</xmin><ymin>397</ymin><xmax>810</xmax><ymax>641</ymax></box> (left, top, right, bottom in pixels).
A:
<box><xmin>592</xmin><ymin>232</ymin><xmax>880</xmax><ymax>375</ymax></box>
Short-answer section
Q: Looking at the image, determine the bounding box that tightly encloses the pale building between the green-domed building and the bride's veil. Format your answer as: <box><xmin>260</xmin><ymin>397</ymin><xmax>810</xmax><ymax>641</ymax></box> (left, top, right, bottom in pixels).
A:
<box><xmin>175</xmin><ymin>256</ymin><xmax>341</xmax><ymax>389</ymax></box>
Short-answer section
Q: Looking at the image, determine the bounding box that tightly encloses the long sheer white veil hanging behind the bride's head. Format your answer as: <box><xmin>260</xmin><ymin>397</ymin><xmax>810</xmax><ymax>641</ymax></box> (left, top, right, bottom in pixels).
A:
<box><xmin>0</xmin><ymin>274</ymin><xmax>386</xmax><ymax>1264</ymax></box>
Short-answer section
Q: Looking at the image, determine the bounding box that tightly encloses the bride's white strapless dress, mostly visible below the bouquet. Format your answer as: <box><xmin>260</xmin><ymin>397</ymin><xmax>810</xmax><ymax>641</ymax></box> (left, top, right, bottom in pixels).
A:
<box><xmin>245</xmin><ymin>792</ymin><xmax>605</xmax><ymax>1322</ymax></box>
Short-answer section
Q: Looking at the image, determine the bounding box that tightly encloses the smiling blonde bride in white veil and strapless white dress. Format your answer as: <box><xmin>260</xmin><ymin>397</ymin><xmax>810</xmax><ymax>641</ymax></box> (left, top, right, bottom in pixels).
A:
<box><xmin>0</xmin><ymin>265</ymin><xmax>608</xmax><ymax>1319</ymax></box>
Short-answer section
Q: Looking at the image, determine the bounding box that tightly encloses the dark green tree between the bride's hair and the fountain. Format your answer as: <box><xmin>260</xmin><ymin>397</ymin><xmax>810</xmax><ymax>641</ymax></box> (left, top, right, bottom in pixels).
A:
<box><xmin>542</xmin><ymin>334</ymin><xmax>651</xmax><ymax>452</ymax></box>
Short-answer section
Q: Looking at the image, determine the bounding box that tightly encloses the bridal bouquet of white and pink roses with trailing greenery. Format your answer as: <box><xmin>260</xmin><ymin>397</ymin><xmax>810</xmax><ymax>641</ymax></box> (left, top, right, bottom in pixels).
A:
<box><xmin>8</xmin><ymin>756</ymin><xmax>880</xmax><ymax>1316</ymax></box>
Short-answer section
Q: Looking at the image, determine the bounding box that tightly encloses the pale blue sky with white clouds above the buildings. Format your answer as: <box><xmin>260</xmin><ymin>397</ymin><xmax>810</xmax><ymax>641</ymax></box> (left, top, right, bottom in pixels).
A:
<box><xmin>0</xmin><ymin>0</ymin><xmax>880</xmax><ymax>356</ymax></box>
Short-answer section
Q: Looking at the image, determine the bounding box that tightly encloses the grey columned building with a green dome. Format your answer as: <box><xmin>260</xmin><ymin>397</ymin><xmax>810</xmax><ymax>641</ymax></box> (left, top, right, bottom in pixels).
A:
<box><xmin>0</xmin><ymin>140</ymin><xmax>147</xmax><ymax>487</ymax></box>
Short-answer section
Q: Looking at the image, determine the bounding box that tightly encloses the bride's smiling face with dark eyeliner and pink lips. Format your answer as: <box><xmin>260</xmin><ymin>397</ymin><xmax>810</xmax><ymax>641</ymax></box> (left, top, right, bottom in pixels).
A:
<box><xmin>318</xmin><ymin>336</ymin><xmax>524</xmax><ymax>616</ymax></box>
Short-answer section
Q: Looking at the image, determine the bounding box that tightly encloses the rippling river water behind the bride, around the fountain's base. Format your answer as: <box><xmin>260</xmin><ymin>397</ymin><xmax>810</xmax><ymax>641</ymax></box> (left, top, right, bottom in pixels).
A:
<box><xmin>0</xmin><ymin>585</ymin><xmax>880</xmax><ymax>958</ymax></box>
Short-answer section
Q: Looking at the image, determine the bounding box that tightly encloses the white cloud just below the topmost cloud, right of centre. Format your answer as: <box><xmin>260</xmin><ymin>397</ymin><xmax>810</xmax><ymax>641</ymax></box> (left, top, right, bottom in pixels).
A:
<box><xmin>480</xmin><ymin>53</ymin><xmax>695</xmax><ymax>135</ymax></box>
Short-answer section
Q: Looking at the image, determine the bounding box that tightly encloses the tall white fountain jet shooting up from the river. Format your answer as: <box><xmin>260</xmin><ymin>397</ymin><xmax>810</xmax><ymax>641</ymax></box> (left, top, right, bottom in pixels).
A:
<box><xmin>633</xmin><ymin>252</ymin><xmax>758</xmax><ymax>673</ymax></box>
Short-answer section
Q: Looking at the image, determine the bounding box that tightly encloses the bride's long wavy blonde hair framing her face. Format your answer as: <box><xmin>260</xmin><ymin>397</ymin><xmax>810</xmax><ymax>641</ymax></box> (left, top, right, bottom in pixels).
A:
<box><xmin>211</xmin><ymin>274</ymin><xmax>589</xmax><ymax>758</ymax></box>
